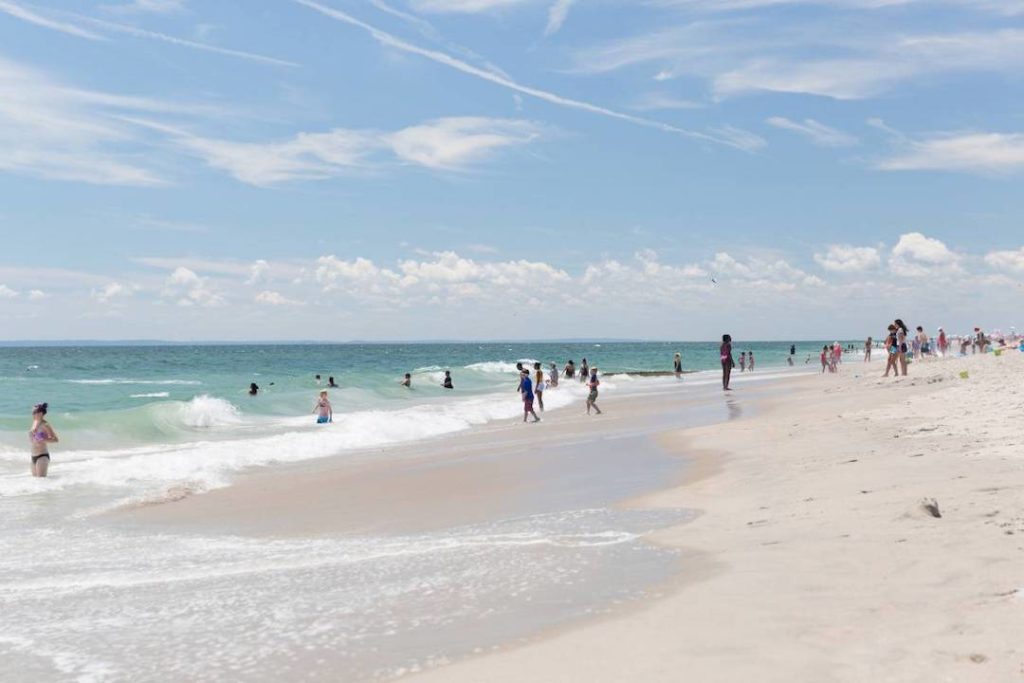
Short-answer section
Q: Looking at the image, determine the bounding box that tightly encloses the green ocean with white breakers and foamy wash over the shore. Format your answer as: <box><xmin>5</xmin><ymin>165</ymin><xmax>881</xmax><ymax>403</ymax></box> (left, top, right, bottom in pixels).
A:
<box><xmin>0</xmin><ymin>342</ymin><xmax>821</xmax><ymax>681</ymax></box>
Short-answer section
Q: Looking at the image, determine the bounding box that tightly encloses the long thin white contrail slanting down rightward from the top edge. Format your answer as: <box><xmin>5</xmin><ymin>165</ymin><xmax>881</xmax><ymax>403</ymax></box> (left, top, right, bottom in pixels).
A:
<box><xmin>294</xmin><ymin>0</ymin><xmax>749</xmax><ymax>146</ymax></box>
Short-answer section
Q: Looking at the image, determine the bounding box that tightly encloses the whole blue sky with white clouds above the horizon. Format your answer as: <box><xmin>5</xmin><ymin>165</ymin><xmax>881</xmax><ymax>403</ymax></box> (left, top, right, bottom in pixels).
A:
<box><xmin>0</xmin><ymin>0</ymin><xmax>1024</xmax><ymax>341</ymax></box>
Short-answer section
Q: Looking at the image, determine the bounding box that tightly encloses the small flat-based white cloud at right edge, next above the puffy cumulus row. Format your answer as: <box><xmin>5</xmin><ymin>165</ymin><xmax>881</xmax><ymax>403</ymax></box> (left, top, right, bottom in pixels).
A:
<box><xmin>877</xmin><ymin>133</ymin><xmax>1024</xmax><ymax>173</ymax></box>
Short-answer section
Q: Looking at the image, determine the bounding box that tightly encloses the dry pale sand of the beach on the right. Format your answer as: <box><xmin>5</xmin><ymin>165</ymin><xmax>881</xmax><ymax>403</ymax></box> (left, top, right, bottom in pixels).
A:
<box><xmin>409</xmin><ymin>352</ymin><xmax>1024</xmax><ymax>683</ymax></box>
